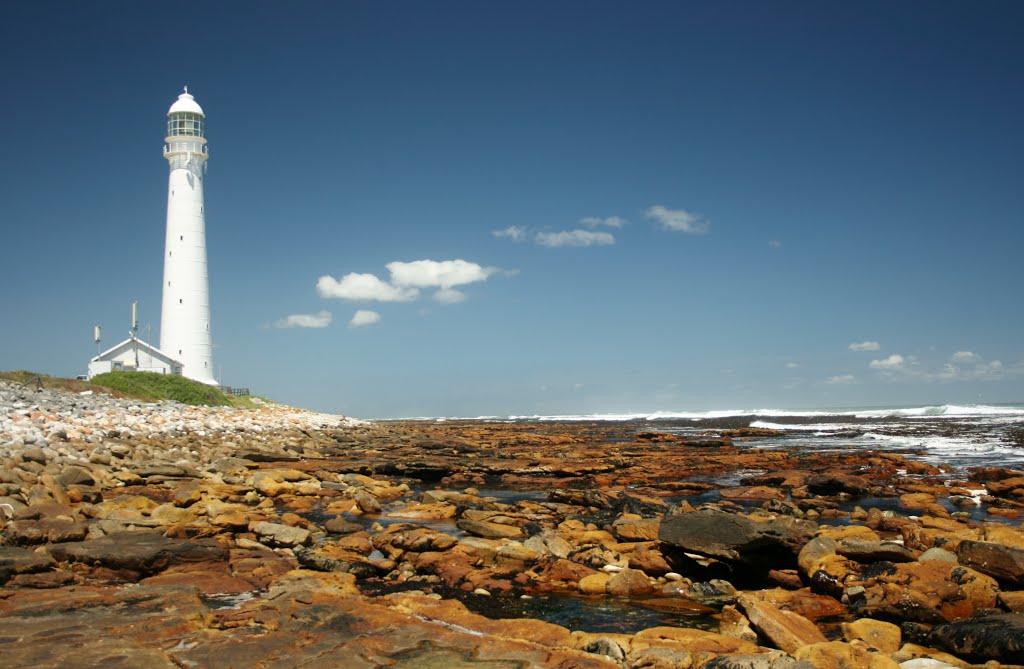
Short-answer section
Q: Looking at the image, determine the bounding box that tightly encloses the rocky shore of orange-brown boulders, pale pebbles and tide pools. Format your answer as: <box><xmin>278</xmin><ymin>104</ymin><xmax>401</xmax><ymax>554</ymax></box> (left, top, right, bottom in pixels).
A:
<box><xmin>0</xmin><ymin>381</ymin><xmax>1024</xmax><ymax>669</ymax></box>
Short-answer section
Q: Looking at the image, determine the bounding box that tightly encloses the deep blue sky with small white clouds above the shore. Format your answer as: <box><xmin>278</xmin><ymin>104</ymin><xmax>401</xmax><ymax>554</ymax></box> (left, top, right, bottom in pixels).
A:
<box><xmin>0</xmin><ymin>1</ymin><xmax>1024</xmax><ymax>417</ymax></box>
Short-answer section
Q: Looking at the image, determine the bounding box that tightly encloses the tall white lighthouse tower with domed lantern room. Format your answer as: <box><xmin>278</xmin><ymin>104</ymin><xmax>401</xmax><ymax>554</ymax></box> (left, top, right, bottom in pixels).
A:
<box><xmin>160</xmin><ymin>86</ymin><xmax>217</xmax><ymax>385</ymax></box>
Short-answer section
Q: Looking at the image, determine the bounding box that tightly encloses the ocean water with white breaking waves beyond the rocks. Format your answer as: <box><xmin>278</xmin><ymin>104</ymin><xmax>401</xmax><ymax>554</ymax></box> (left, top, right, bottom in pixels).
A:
<box><xmin>462</xmin><ymin>404</ymin><xmax>1024</xmax><ymax>475</ymax></box>
